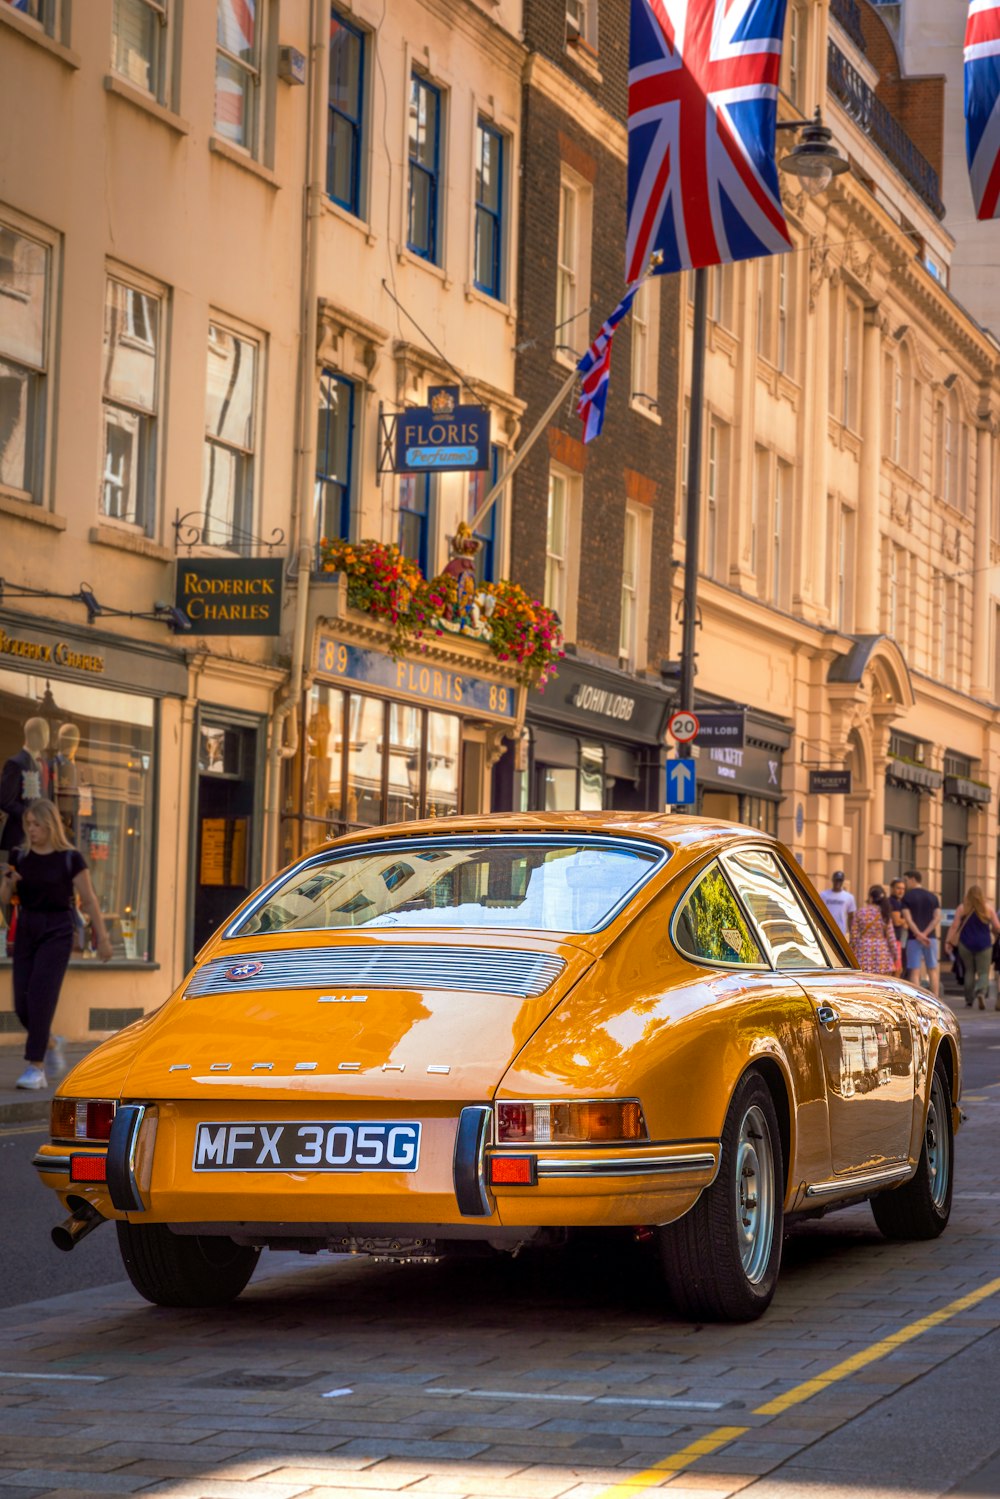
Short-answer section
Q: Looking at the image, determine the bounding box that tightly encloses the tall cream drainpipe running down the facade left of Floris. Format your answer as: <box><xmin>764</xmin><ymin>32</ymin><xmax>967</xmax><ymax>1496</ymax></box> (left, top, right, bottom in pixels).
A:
<box><xmin>264</xmin><ymin>0</ymin><xmax>330</xmax><ymax>877</ymax></box>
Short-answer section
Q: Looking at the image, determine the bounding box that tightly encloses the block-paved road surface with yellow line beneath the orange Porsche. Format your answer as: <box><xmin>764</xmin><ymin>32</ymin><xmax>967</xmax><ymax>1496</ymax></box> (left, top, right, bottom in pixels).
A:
<box><xmin>0</xmin><ymin>1013</ymin><xmax>1000</xmax><ymax>1499</ymax></box>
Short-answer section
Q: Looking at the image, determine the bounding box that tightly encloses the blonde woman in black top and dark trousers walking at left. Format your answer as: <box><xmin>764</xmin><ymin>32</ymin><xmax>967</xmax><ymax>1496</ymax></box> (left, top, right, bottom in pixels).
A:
<box><xmin>0</xmin><ymin>800</ymin><xmax>111</xmax><ymax>1088</ymax></box>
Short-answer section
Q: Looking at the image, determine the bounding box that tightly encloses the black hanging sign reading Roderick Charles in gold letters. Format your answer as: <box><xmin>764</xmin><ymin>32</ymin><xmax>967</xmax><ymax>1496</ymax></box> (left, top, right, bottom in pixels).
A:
<box><xmin>175</xmin><ymin>558</ymin><xmax>283</xmax><ymax>636</ymax></box>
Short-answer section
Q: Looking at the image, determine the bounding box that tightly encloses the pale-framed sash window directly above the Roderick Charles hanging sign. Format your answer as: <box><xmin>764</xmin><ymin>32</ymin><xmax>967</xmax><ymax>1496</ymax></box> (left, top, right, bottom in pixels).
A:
<box><xmin>202</xmin><ymin>322</ymin><xmax>259</xmax><ymax>552</ymax></box>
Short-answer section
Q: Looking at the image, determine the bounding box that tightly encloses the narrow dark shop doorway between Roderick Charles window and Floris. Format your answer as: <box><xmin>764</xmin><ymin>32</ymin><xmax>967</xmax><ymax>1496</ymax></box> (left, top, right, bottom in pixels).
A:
<box><xmin>189</xmin><ymin>711</ymin><xmax>262</xmax><ymax>956</ymax></box>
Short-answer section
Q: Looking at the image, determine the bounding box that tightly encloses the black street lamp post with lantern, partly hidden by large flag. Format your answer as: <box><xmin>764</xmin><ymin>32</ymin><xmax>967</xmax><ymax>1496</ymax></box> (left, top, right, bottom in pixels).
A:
<box><xmin>678</xmin><ymin>105</ymin><xmax>850</xmax><ymax>806</ymax></box>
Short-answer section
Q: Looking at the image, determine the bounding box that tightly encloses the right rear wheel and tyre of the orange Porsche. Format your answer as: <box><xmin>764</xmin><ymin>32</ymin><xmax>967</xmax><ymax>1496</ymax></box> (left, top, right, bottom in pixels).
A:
<box><xmin>658</xmin><ymin>1072</ymin><xmax>784</xmax><ymax>1322</ymax></box>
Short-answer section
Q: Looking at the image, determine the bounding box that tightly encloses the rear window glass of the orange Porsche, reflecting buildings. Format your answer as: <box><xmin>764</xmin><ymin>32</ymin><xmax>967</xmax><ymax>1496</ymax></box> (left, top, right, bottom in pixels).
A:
<box><xmin>226</xmin><ymin>838</ymin><xmax>667</xmax><ymax>937</ymax></box>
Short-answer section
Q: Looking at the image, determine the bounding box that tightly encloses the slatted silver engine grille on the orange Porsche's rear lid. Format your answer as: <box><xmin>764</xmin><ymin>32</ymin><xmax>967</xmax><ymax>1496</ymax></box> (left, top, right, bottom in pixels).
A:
<box><xmin>186</xmin><ymin>947</ymin><xmax>565</xmax><ymax>1000</ymax></box>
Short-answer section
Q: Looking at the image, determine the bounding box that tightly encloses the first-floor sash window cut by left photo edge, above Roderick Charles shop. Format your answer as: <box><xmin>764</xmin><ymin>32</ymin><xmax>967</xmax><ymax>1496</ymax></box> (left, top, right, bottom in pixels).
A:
<box><xmin>0</xmin><ymin>222</ymin><xmax>51</xmax><ymax>505</ymax></box>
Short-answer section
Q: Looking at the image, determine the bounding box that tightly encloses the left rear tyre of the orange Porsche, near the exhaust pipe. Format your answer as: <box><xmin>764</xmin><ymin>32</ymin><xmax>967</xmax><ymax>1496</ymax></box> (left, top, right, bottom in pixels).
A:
<box><xmin>117</xmin><ymin>1223</ymin><xmax>261</xmax><ymax>1307</ymax></box>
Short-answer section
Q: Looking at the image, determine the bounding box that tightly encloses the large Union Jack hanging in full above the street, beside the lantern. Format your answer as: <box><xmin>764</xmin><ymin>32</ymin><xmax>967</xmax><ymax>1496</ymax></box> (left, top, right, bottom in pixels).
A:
<box><xmin>625</xmin><ymin>0</ymin><xmax>792</xmax><ymax>282</ymax></box>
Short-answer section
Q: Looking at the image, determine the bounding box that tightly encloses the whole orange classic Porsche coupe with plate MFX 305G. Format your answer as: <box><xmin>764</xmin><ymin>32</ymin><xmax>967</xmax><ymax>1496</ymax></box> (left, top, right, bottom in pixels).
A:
<box><xmin>34</xmin><ymin>812</ymin><xmax>961</xmax><ymax>1321</ymax></box>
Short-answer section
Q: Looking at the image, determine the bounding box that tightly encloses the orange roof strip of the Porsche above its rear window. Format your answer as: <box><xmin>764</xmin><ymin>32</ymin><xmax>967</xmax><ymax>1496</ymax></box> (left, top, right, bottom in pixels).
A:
<box><xmin>322</xmin><ymin>811</ymin><xmax>775</xmax><ymax>853</ymax></box>
